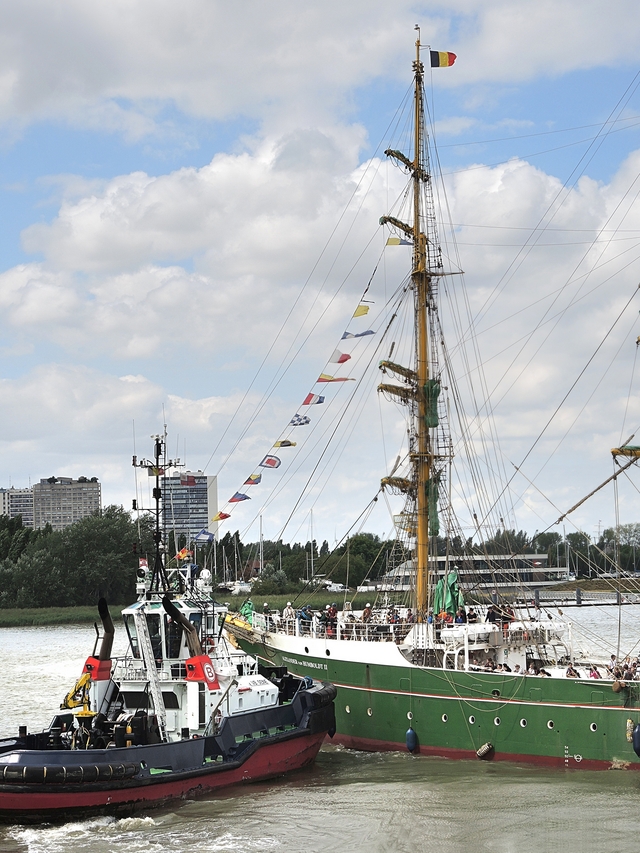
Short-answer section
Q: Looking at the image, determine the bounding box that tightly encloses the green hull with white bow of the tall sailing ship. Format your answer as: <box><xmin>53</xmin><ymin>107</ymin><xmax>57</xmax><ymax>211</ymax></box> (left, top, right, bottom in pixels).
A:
<box><xmin>236</xmin><ymin>635</ymin><xmax>640</xmax><ymax>770</ymax></box>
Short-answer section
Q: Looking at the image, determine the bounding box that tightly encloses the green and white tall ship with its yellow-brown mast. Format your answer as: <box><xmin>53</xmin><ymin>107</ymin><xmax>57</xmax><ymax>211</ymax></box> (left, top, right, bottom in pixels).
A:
<box><xmin>226</xmin><ymin>36</ymin><xmax>640</xmax><ymax>770</ymax></box>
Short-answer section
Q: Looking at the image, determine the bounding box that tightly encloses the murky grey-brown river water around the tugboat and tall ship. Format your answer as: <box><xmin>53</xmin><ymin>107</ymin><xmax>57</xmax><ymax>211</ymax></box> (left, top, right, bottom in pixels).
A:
<box><xmin>0</xmin><ymin>606</ymin><xmax>640</xmax><ymax>853</ymax></box>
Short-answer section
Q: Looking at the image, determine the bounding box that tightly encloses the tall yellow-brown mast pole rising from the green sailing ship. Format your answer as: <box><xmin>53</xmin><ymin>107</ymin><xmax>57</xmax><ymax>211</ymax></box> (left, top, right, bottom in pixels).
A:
<box><xmin>411</xmin><ymin>37</ymin><xmax>431</xmax><ymax>620</ymax></box>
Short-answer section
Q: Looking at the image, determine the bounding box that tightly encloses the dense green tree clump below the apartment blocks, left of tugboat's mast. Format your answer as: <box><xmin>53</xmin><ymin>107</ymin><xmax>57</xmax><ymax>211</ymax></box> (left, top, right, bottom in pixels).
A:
<box><xmin>0</xmin><ymin>506</ymin><xmax>153</xmax><ymax>608</ymax></box>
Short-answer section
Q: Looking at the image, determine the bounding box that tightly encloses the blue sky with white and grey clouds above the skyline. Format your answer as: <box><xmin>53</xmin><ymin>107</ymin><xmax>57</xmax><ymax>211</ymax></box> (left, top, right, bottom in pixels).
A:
<box><xmin>0</xmin><ymin>0</ymin><xmax>640</xmax><ymax>544</ymax></box>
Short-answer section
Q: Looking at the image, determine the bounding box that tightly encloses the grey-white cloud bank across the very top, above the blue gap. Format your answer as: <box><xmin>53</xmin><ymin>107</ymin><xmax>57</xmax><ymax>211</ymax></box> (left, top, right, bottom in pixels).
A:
<box><xmin>0</xmin><ymin>0</ymin><xmax>640</xmax><ymax>139</ymax></box>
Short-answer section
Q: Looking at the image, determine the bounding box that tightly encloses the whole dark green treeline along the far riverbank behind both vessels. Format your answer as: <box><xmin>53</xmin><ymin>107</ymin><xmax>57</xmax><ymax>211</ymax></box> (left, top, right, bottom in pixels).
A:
<box><xmin>0</xmin><ymin>506</ymin><xmax>640</xmax><ymax>608</ymax></box>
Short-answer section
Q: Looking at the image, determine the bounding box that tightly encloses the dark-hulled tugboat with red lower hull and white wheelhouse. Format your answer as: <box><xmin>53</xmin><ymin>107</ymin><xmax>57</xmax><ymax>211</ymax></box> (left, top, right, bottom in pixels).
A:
<box><xmin>0</xmin><ymin>436</ymin><xmax>336</xmax><ymax>823</ymax></box>
